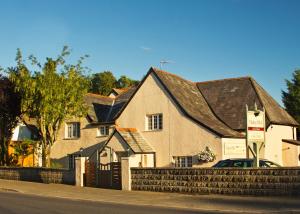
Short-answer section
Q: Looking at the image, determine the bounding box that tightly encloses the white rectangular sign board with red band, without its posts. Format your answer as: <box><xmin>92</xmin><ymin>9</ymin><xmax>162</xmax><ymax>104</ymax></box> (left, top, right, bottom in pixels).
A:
<box><xmin>247</xmin><ymin>110</ymin><xmax>265</xmax><ymax>143</ymax></box>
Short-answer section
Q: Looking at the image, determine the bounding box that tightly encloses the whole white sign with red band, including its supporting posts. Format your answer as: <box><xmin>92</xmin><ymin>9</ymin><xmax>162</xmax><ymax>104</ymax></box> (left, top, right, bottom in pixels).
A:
<box><xmin>246</xmin><ymin>103</ymin><xmax>266</xmax><ymax>167</ymax></box>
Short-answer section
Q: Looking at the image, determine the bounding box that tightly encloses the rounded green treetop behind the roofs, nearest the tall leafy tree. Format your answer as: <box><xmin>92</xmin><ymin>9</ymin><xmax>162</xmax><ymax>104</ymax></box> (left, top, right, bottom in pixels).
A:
<box><xmin>90</xmin><ymin>71</ymin><xmax>116</xmax><ymax>95</ymax></box>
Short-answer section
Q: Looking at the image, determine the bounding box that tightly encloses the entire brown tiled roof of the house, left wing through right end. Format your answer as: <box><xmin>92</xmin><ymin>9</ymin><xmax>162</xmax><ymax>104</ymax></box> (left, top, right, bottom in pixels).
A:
<box><xmin>86</xmin><ymin>68</ymin><xmax>298</xmax><ymax>137</ymax></box>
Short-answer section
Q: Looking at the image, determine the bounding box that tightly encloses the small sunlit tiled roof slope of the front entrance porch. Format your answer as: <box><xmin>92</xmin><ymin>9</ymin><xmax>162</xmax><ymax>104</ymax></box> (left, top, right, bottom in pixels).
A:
<box><xmin>116</xmin><ymin>128</ymin><xmax>154</xmax><ymax>153</ymax></box>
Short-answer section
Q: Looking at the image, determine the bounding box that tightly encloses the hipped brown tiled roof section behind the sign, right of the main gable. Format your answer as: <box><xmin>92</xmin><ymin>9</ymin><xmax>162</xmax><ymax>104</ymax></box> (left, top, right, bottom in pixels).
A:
<box><xmin>197</xmin><ymin>77</ymin><xmax>298</xmax><ymax>130</ymax></box>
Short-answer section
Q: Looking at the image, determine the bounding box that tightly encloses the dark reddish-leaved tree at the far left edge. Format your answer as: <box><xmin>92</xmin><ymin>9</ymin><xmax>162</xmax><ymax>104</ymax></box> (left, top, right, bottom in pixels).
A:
<box><xmin>0</xmin><ymin>74</ymin><xmax>21</xmax><ymax>165</ymax></box>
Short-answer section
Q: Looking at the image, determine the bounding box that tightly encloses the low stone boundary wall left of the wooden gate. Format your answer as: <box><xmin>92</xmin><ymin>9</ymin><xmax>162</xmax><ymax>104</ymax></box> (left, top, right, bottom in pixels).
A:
<box><xmin>0</xmin><ymin>167</ymin><xmax>75</xmax><ymax>185</ymax></box>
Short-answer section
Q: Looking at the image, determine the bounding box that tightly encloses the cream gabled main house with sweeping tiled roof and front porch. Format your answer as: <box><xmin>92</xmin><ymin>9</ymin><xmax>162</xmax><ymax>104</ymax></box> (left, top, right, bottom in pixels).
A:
<box><xmin>100</xmin><ymin>68</ymin><xmax>300</xmax><ymax>167</ymax></box>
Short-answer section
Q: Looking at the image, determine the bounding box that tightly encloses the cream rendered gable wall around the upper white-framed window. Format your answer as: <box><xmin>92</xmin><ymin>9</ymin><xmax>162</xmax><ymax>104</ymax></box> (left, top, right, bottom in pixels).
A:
<box><xmin>116</xmin><ymin>74</ymin><xmax>222</xmax><ymax>167</ymax></box>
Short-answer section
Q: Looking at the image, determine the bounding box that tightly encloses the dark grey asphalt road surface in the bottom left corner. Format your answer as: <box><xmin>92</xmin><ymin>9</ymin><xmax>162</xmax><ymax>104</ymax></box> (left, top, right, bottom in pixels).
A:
<box><xmin>0</xmin><ymin>192</ymin><xmax>230</xmax><ymax>214</ymax></box>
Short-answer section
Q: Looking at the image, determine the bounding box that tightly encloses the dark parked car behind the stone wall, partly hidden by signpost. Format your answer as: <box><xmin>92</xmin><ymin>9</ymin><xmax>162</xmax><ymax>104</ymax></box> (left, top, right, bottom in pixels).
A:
<box><xmin>212</xmin><ymin>158</ymin><xmax>281</xmax><ymax>168</ymax></box>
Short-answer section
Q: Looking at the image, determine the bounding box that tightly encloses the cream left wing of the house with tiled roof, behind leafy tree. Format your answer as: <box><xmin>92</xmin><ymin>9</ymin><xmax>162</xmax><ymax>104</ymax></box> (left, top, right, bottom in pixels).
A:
<box><xmin>50</xmin><ymin>87</ymin><xmax>135</xmax><ymax>168</ymax></box>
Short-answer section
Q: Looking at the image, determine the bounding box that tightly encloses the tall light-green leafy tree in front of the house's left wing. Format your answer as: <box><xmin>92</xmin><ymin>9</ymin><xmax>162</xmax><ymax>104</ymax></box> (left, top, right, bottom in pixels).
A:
<box><xmin>9</xmin><ymin>46</ymin><xmax>89</xmax><ymax>167</ymax></box>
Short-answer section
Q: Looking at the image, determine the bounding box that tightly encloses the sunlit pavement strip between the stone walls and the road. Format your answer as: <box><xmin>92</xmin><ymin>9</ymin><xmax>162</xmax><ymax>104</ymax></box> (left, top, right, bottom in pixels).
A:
<box><xmin>0</xmin><ymin>179</ymin><xmax>300</xmax><ymax>213</ymax></box>
